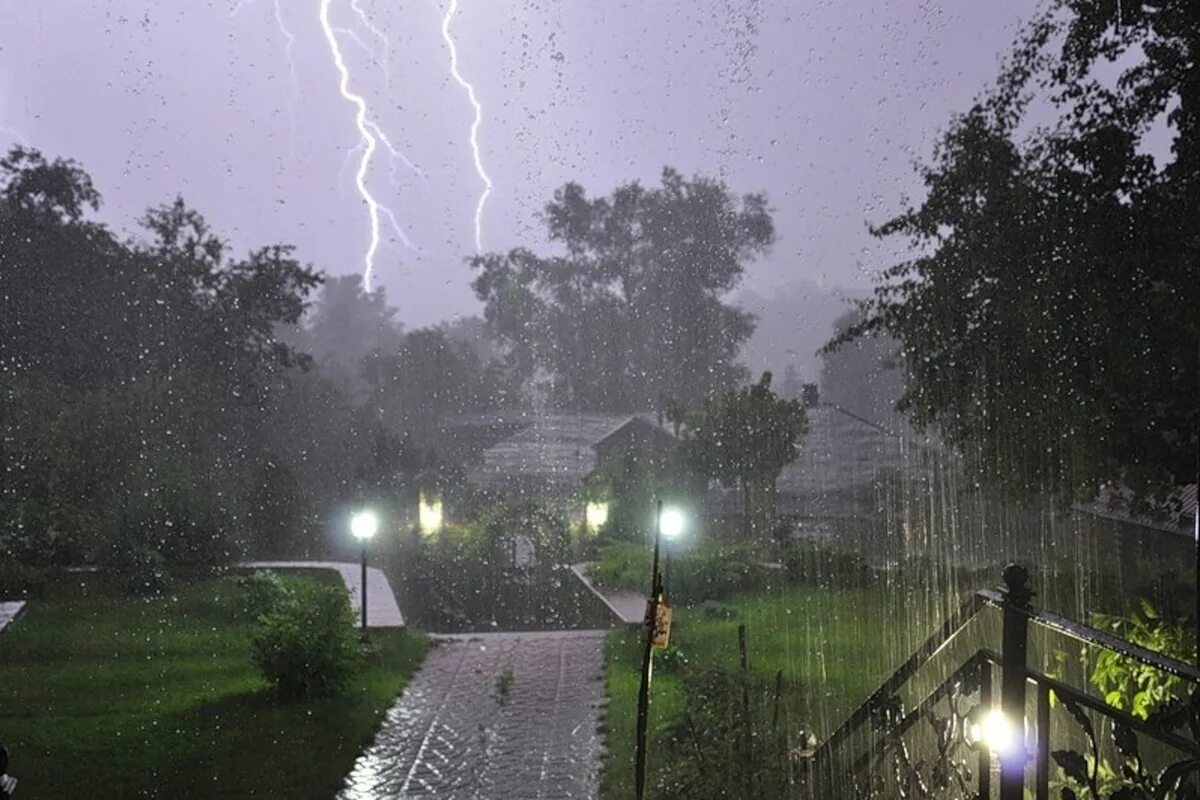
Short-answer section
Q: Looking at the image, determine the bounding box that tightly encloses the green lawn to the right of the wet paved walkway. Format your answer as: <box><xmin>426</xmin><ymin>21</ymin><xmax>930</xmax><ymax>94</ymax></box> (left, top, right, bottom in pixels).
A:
<box><xmin>601</xmin><ymin>587</ymin><xmax>926</xmax><ymax>800</ymax></box>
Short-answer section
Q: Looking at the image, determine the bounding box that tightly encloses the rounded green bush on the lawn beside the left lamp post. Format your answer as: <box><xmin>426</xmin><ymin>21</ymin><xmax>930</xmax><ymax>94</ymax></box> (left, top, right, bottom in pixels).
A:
<box><xmin>253</xmin><ymin>582</ymin><xmax>361</xmax><ymax>700</ymax></box>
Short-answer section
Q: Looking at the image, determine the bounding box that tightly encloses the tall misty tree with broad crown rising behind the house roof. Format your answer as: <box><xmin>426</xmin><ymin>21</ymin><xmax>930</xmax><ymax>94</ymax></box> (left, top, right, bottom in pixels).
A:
<box><xmin>470</xmin><ymin>168</ymin><xmax>774</xmax><ymax>410</ymax></box>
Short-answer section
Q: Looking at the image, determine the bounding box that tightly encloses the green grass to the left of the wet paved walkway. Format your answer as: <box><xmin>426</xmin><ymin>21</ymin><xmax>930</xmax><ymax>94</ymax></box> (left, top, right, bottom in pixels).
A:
<box><xmin>0</xmin><ymin>576</ymin><xmax>428</xmax><ymax>798</ymax></box>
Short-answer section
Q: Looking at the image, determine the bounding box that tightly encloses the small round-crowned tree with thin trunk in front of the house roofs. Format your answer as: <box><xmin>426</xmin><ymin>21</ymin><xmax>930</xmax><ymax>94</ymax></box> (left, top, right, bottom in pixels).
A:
<box><xmin>684</xmin><ymin>372</ymin><xmax>809</xmax><ymax>537</ymax></box>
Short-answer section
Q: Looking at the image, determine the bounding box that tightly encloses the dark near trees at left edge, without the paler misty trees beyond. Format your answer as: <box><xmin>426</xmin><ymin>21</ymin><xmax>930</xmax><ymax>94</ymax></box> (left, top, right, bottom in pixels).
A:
<box><xmin>0</xmin><ymin>148</ymin><xmax>320</xmax><ymax>564</ymax></box>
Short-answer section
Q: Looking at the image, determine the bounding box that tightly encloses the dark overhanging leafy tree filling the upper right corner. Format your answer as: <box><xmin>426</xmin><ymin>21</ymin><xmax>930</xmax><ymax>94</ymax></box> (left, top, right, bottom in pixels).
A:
<box><xmin>834</xmin><ymin>0</ymin><xmax>1200</xmax><ymax>497</ymax></box>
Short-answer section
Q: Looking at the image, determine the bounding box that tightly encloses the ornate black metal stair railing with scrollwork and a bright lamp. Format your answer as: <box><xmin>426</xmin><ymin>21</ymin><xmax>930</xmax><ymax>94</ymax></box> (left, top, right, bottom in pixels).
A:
<box><xmin>805</xmin><ymin>565</ymin><xmax>1200</xmax><ymax>800</ymax></box>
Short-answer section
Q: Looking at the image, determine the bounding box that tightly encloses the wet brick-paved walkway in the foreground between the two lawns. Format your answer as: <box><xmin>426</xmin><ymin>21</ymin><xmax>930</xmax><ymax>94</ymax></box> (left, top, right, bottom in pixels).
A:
<box><xmin>340</xmin><ymin>631</ymin><xmax>605</xmax><ymax>800</ymax></box>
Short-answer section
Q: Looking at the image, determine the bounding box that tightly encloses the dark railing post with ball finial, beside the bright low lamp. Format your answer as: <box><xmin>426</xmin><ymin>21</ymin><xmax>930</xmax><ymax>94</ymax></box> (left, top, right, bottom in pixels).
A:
<box><xmin>1000</xmin><ymin>564</ymin><xmax>1033</xmax><ymax>800</ymax></box>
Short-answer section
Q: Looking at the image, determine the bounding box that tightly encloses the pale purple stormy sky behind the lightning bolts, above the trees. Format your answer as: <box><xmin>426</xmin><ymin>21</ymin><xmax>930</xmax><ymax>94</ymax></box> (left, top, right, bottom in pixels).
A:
<box><xmin>0</xmin><ymin>0</ymin><xmax>1037</xmax><ymax>325</ymax></box>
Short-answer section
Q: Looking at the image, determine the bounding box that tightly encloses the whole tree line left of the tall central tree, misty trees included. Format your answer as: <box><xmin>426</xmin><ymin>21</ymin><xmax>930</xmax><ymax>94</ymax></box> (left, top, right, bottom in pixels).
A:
<box><xmin>0</xmin><ymin>148</ymin><xmax>515</xmax><ymax>569</ymax></box>
